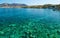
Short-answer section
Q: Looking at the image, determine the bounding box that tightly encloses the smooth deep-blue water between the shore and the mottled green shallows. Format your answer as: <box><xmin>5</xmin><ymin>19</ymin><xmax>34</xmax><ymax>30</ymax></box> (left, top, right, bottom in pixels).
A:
<box><xmin>0</xmin><ymin>8</ymin><xmax>60</xmax><ymax>23</ymax></box>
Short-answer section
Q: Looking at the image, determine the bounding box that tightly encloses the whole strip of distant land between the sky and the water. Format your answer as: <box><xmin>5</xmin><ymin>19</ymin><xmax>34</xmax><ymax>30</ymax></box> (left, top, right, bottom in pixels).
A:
<box><xmin>0</xmin><ymin>3</ymin><xmax>60</xmax><ymax>9</ymax></box>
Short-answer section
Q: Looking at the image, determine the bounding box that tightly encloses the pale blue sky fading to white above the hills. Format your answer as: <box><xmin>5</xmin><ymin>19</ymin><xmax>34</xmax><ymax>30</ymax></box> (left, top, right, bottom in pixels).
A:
<box><xmin>0</xmin><ymin>0</ymin><xmax>60</xmax><ymax>5</ymax></box>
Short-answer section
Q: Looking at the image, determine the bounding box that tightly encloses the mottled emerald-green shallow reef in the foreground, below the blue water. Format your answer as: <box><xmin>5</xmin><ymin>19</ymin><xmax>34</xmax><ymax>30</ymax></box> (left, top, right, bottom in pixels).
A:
<box><xmin>0</xmin><ymin>20</ymin><xmax>60</xmax><ymax>38</ymax></box>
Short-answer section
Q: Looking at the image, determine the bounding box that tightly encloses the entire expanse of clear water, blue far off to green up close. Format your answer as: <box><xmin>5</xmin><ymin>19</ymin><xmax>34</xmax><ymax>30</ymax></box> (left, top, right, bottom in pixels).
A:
<box><xmin>0</xmin><ymin>8</ymin><xmax>60</xmax><ymax>38</ymax></box>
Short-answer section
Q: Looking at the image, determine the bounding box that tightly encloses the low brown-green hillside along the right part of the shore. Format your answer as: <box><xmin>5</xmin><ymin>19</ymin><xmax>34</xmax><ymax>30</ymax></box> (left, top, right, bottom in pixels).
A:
<box><xmin>24</xmin><ymin>4</ymin><xmax>60</xmax><ymax>9</ymax></box>
